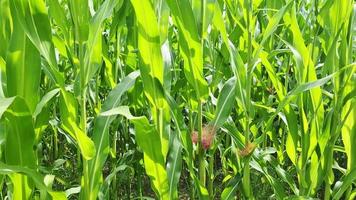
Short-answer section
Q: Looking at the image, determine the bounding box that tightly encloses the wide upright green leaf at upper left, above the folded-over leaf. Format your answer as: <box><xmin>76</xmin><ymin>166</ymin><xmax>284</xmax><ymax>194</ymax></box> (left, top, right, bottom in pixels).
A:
<box><xmin>6</xmin><ymin>14</ymin><xmax>41</xmax><ymax>112</ymax></box>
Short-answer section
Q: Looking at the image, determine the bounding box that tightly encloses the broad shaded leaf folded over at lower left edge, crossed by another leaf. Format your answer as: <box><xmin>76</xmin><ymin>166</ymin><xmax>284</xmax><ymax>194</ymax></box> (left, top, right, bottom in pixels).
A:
<box><xmin>0</xmin><ymin>97</ymin><xmax>37</xmax><ymax>199</ymax></box>
